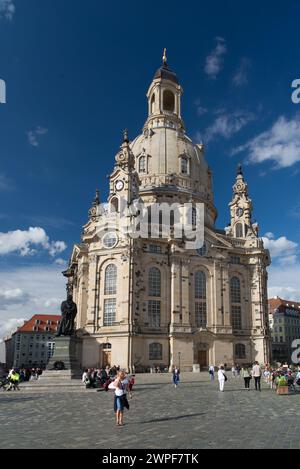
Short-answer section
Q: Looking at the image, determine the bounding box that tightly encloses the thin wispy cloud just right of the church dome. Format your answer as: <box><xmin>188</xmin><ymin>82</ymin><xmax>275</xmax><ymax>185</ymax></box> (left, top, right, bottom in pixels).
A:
<box><xmin>197</xmin><ymin>110</ymin><xmax>254</xmax><ymax>142</ymax></box>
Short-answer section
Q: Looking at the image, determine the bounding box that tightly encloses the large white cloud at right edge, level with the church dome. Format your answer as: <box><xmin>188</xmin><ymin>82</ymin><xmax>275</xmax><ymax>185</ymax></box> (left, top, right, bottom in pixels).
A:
<box><xmin>232</xmin><ymin>114</ymin><xmax>300</xmax><ymax>169</ymax></box>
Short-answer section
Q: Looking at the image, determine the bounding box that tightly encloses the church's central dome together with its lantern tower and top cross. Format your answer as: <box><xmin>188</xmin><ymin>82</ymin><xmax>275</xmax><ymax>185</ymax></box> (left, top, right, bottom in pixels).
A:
<box><xmin>131</xmin><ymin>48</ymin><xmax>217</xmax><ymax>228</ymax></box>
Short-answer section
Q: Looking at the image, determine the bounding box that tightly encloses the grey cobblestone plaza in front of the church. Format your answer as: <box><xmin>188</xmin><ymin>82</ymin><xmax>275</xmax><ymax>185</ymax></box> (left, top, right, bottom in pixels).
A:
<box><xmin>0</xmin><ymin>373</ymin><xmax>300</xmax><ymax>449</ymax></box>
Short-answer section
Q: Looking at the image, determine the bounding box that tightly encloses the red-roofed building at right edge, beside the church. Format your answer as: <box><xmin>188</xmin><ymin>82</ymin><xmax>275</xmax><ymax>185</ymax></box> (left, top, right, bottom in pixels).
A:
<box><xmin>268</xmin><ymin>296</ymin><xmax>300</xmax><ymax>363</ymax></box>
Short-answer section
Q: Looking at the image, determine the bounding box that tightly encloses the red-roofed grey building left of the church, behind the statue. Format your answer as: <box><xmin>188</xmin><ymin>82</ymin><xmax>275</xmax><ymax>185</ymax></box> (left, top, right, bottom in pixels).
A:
<box><xmin>5</xmin><ymin>314</ymin><xmax>61</xmax><ymax>368</ymax></box>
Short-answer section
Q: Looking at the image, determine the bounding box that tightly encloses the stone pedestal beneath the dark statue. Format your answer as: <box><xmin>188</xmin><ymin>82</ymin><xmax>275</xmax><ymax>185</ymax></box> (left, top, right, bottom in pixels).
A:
<box><xmin>46</xmin><ymin>336</ymin><xmax>82</xmax><ymax>378</ymax></box>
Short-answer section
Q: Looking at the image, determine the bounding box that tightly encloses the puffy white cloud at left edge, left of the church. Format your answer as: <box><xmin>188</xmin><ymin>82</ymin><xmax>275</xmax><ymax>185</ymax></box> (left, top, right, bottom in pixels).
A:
<box><xmin>0</xmin><ymin>227</ymin><xmax>67</xmax><ymax>257</ymax></box>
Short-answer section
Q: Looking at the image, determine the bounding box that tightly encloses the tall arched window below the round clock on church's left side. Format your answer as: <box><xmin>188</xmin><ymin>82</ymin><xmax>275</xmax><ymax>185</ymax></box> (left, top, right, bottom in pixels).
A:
<box><xmin>103</xmin><ymin>264</ymin><xmax>117</xmax><ymax>326</ymax></box>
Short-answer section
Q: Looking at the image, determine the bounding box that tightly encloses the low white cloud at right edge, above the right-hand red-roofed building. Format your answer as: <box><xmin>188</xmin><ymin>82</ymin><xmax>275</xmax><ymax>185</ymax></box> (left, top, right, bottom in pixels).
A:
<box><xmin>262</xmin><ymin>233</ymin><xmax>298</xmax><ymax>264</ymax></box>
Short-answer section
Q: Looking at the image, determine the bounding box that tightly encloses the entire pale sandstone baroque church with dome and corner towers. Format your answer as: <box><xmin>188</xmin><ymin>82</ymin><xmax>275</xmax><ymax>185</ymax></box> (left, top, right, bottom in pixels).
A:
<box><xmin>64</xmin><ymin>53</ymin><xmax>270</xmax><ymax>372</ymax></box>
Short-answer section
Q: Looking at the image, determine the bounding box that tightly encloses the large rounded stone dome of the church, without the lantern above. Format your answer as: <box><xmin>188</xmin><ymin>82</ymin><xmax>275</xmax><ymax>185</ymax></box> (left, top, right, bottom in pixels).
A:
<box><xmin>130</xmin><ymin>126</ymin><xmax>216</xmax><ymax>225</ymax></box>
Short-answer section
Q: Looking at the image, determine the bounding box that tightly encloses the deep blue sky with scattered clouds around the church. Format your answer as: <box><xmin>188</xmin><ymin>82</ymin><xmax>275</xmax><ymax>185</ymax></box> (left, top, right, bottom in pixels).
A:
<box><xmin>0</xmin><ymin>0</ymin><xmax>300</xmax><ymax>346</ymax></box>
